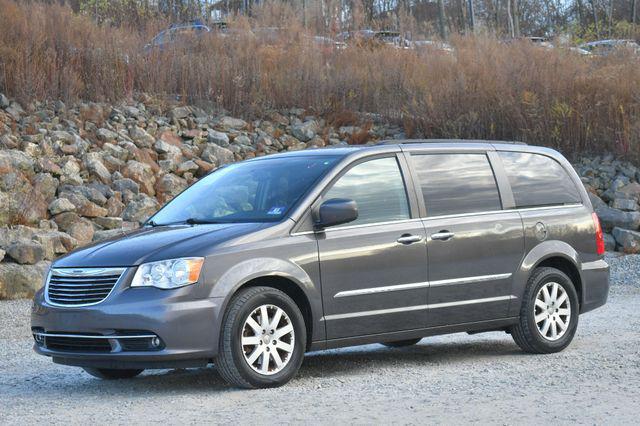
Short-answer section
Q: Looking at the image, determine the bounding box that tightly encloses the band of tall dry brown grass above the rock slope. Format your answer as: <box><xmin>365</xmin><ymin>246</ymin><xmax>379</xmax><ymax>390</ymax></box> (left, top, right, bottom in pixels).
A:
<box><xmin>0</xmin><ymin>0</ymin><xmax>640</xmax><ymax>159</ymax></box>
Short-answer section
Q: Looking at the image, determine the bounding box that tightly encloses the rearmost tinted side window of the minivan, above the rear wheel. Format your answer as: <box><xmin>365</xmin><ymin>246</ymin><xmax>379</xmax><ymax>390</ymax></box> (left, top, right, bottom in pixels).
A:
<box><xmin>499</xmin><ymin>152</ymin><xmax>580</xmax><ymax>207</ymax></box>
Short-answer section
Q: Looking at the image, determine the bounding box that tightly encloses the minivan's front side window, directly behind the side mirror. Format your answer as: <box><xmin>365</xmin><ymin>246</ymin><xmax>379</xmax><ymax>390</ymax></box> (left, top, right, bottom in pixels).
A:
<box><xmin>324</xmin><ymin>158</ymin><xmax>410</xmax><ymax>225</ymax></box>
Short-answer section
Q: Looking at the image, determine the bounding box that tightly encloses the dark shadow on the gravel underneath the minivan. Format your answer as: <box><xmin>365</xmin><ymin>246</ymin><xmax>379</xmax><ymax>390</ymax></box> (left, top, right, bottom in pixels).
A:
<box><xmin>35</xmin><ymin>339</ymin><xmax>523</xmax><ymax>395</ymax></box>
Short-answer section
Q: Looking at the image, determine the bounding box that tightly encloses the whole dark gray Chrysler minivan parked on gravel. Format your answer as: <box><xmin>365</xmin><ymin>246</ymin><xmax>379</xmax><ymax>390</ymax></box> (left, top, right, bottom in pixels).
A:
<box><xmin>32</xmin><ymin>140</ymin><xmax>609</xmax><ymax>388</ymax></box>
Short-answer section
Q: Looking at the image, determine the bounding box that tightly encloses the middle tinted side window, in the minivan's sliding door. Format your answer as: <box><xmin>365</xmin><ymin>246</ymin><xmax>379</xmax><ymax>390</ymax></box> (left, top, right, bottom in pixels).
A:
<box><xmin>412</xmin><ymin>154</ymin><xmax>502</xmax><ymax>216</ymax></box>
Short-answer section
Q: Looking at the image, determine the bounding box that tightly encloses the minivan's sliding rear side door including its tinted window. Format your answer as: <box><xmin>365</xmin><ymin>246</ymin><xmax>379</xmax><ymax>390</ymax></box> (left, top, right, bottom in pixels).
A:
<box><xmin>410</xmin><ymin>151</ymin><xmax>524</xmax><ymax>327</ymax></box>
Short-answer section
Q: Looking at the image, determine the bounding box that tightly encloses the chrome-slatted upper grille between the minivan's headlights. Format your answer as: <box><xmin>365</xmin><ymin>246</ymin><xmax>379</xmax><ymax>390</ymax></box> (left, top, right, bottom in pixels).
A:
<box><xmin>45</xmin><ymin>268</ymin><xmax>124</xmax><ymax>306</ymax></box>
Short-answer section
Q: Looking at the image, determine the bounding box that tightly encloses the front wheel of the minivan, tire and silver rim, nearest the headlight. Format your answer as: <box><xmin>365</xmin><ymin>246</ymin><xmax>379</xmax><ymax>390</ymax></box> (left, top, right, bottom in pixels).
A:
<box><xmin>216</xmin><ymin>287</ymin><xmax>307</xmax><ymax>389</ymax></box>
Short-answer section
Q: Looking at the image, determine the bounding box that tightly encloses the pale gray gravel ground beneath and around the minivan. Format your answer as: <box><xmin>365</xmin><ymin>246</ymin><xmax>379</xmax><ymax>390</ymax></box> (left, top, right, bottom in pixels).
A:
<box><xmin>0</xmin><ymin>256</ymin><xmax>640</xmax><ymax>424</ymax></box>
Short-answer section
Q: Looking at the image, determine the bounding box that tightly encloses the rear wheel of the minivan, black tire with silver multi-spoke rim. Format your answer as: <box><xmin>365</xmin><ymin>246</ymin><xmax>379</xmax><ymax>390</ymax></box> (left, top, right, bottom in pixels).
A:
<box><xmin>510</xmin><ymin>267</ymin><xmax>580</xmax><ymax>354</ymax></box>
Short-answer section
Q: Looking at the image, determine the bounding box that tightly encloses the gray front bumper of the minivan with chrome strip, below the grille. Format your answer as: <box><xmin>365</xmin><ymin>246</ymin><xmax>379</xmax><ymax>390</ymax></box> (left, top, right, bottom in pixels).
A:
<box><xmin>31</xmin><ymin>272</ymin><xmax>223</xmax><ymax>368</ymax></box>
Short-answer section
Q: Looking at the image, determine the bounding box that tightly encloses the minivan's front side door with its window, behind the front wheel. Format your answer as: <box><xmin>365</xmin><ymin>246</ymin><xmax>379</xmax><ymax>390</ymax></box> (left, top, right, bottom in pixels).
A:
<box><xmin>317</xmin><ymin>155</ymin><xmax>428</xmax><ymax>339</ymax></box>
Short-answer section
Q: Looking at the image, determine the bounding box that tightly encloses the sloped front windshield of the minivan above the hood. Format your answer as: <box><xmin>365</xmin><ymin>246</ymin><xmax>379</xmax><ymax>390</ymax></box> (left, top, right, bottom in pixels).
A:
<box><xmin>149</xmin><ymin>156</ymin><xmax>339</xmax><ymax>226</ymax></box>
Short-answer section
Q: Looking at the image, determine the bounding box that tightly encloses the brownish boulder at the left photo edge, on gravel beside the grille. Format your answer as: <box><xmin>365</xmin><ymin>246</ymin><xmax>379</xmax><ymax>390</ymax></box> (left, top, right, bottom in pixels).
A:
<box><xmin>0</xmin><ymin>262</ymin><xmax>50</xmax><ymax>299</ymax></box>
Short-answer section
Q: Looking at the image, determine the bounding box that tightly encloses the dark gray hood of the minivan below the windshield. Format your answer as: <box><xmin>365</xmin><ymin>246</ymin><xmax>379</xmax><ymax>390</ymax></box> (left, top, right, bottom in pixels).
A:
<box><xmin>53</xmin><ymin>223</ymin><xmax>268</xmax><ymax>268</ymax></box>
